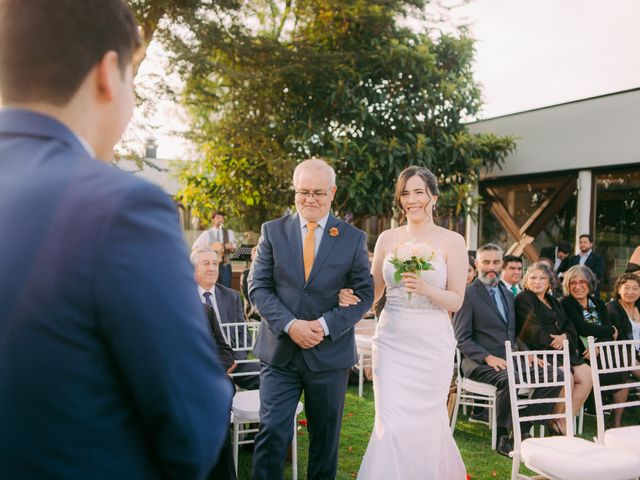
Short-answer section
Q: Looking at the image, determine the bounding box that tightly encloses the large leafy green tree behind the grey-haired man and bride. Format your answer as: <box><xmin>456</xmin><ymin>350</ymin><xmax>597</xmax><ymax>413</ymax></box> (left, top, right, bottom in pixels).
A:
<box><xmin>166</xmin><ymin>0</ymin><xmax>515</xmax><ymax>229</ymax></box>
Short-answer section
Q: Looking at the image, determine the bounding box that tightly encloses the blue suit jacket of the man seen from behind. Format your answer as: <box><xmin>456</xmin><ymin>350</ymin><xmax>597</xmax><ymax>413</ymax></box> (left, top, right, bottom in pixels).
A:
<box><xmin>0</xmin><ymin>109</ymin><xmax>232</xmax><ymax>480</ymax></box>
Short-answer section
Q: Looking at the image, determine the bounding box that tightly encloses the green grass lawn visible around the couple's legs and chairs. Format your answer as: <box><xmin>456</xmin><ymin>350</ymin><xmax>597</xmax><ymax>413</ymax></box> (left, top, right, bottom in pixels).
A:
<box><xmin>238</xmin><ymin>383</ymin><xmax>635</xmax><ymax>480</ymax></box>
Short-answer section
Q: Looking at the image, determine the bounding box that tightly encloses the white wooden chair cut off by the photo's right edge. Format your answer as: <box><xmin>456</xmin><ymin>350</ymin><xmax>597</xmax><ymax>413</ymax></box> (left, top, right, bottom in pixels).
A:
<box><xmin>588</xmin><ymin>337</ymin><xmax>640</xmax><ymax>455</ymax></box>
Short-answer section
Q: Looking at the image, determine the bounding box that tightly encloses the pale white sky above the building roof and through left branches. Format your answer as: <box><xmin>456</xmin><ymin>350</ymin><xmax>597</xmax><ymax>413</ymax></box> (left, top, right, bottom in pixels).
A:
<box><xmin>138</xmin><ymin>0</ymin><xmax>640</xmax><ymax>158</ymax></box>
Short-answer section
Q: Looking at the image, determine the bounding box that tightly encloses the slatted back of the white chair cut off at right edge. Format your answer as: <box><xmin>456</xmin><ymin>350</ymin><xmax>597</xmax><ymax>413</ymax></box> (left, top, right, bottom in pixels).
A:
<box><xmin>587</xmin><ymin>337</ymin><xmax>640</xmax><ymax>444</ymax></box>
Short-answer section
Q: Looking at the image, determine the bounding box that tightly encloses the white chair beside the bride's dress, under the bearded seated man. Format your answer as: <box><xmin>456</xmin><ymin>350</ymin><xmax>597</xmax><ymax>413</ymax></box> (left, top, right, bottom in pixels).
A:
<box><xmin>451</xmin><ymin>348</ymin><xmax>498</xmax><ymax>450</ymax></box>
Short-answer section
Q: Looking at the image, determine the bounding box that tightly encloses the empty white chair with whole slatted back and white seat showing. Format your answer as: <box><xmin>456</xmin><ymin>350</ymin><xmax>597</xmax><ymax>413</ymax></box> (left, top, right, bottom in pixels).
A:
<box><xmin>505</xmin><ymin>340</ymin><xmax>640</xmax><ymax>480</ymax></box>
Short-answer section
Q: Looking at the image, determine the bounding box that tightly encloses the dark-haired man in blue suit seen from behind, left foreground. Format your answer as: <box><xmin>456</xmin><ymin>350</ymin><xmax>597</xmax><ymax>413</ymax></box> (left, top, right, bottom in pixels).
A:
<box><xmin>0</xmin><ymin>0</ymin><xmax>232</xmax><ymax>480</ymax></box>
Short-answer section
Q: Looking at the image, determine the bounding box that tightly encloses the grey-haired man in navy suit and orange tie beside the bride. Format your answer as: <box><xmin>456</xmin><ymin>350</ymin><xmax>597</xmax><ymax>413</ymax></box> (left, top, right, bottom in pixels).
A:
<box><xmin>249</xmin><ymin>159</ymin><xmax>373</xmax><ymax>480</ymax></box>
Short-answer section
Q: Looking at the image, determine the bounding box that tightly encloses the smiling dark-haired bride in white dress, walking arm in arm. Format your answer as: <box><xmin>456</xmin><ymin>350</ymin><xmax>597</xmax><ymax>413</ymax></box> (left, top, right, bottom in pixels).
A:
<box><xmin>340</xmin><ymin>166</ymin><xmax>468</xmax><ymax>480</ymax></box>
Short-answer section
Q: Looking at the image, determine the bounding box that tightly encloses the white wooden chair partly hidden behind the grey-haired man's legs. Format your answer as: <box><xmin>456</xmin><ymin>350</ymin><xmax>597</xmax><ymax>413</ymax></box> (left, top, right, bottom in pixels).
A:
<box><xmin>220</xmin><ymin>322</ymin><xmax>304</xmax><ymax>480</ymax></box>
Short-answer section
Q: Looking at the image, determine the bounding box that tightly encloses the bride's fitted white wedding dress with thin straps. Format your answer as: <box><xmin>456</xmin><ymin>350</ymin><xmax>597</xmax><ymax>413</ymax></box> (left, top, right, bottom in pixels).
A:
<box><xmin>358</xmin><ymin>254</ymin><xmax>466</xmax><ymax>480</ymax></box>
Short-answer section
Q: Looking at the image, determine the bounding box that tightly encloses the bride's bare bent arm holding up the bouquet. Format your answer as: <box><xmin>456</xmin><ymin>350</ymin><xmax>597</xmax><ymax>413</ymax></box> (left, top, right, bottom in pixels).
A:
<box><xmin>403</xmin><ymin>232</ymin><xmax>469</xmax><ymax>312</ymax></box>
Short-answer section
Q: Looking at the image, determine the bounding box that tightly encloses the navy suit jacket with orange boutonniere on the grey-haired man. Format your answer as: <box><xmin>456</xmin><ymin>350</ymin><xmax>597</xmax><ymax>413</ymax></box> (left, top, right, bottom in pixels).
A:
<box><xmin>249</xmin><ymin>214</ymin><xmax>373</xmax><ymax>371</ymax></box>
